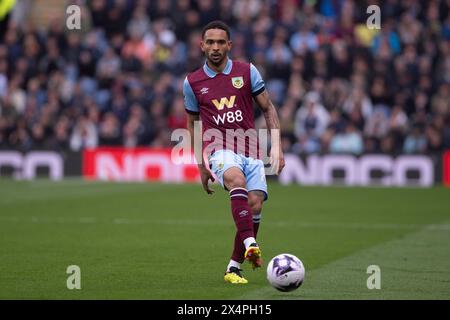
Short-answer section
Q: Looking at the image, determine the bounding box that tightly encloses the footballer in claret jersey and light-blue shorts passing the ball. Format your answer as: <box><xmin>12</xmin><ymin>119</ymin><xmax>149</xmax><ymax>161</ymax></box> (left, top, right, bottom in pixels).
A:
<box><xmin>183</xmin><ymin>21</ymin><xmax>284</xmax><ymax>284</ymax></box>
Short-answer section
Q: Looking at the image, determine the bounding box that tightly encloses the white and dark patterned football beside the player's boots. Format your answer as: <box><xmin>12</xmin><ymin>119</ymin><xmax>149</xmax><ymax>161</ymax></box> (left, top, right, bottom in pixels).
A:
<box><xmin>267</xmin><ymin>253</ymin><xmax>305</xmax><ymax>292</ymax></box>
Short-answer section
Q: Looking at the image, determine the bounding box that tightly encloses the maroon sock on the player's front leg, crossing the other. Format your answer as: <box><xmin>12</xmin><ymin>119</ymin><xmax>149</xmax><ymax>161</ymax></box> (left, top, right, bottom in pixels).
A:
<box><xmin>230</xmin><ymin>188</ymin><xmax>255</xmax><ymax>249</ymax></box>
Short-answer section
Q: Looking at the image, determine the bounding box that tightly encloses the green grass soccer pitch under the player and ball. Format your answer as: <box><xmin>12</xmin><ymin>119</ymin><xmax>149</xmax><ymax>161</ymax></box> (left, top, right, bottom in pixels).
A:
<box><xmin>0</xmin><ymin>180</ymin><xmax>450</xmax><ymax>300</ymax></box>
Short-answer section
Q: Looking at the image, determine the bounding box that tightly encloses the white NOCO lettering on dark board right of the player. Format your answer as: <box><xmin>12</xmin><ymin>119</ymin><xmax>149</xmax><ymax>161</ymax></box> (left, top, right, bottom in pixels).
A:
<box><xmin>280</xmin><ymin>154</ymin><xmax>434</xmax><ymax>187</ymax></box>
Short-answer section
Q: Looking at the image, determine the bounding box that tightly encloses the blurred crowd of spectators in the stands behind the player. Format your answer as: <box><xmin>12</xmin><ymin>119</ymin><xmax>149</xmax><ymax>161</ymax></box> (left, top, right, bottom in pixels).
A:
<box><xmin>0</xmin><ymin>0</ymin><xmax>450</xmax><ymax>154</ymax></box>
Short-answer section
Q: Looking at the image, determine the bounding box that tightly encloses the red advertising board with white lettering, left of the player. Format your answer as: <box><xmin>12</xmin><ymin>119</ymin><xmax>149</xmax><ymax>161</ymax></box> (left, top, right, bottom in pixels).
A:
<box><xmin>83</xmin><ymin>148</ymin><xmax>200</xmax><ymax>182</ymax></box>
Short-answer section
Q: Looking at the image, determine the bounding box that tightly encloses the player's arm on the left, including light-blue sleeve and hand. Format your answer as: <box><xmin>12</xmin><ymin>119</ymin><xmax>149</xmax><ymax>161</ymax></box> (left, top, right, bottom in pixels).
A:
<box><xmin>183</xmin><ymin>78</ymin><xmax>215</xmax><ymax>194</ymax></box>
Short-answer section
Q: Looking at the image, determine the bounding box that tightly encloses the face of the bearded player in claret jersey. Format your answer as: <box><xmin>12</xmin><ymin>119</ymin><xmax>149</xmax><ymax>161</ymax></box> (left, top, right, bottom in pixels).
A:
<box><xmin>201</xmin><ymin>29</ymin><xmax>231</xmax><ymax>66</ymax></box>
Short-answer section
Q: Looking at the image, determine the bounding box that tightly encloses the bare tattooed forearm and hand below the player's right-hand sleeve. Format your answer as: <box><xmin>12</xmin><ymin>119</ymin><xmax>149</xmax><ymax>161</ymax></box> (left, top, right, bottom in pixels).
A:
<box><xmin>255</xmin><ymin>90</ymin><xmax>284</xmax><ymax>174</ymax></box>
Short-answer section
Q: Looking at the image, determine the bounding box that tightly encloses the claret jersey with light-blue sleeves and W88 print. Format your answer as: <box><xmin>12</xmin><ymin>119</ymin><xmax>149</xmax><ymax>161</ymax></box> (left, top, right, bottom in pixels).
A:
<box><xmin>183</xmin><ymin>59</ymin><xmax>265</xmax><ymax>157</ymax></box>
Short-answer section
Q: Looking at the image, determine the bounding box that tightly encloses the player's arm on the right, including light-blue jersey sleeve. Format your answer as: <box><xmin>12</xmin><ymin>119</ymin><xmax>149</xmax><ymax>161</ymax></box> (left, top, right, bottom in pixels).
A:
<box><xmin>250</xmin><ymin>64</ymin><xmax>284</xmax><ymax>174</ymax></box>
